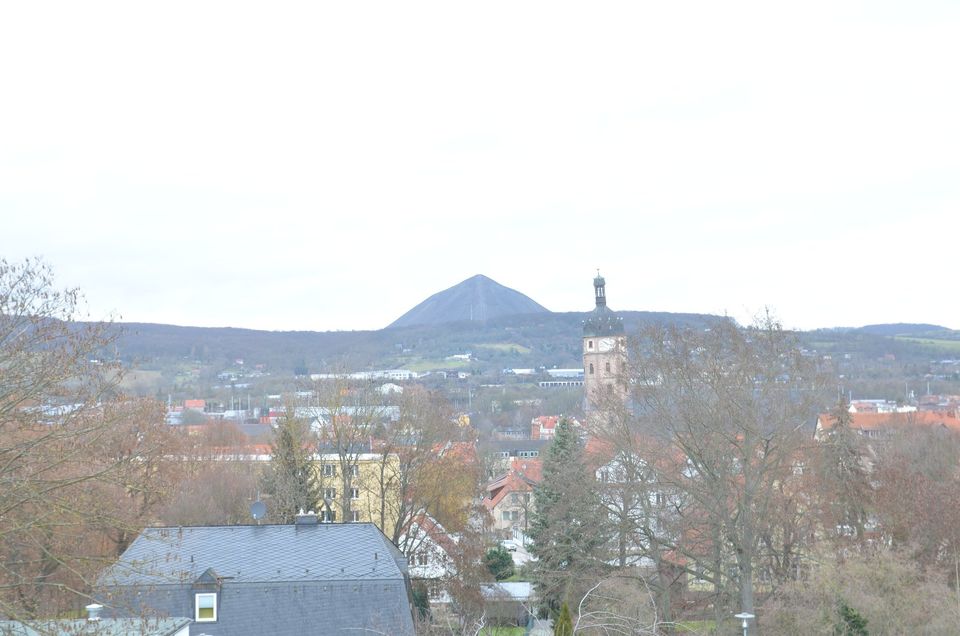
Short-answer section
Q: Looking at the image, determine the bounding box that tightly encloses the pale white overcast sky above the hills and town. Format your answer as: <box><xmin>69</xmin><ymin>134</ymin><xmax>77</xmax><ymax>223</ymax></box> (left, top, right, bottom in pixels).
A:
<box><xmin>0</xmin><ymin>0</ymin><xmax>960</xmax><ymax>330</ymax></box>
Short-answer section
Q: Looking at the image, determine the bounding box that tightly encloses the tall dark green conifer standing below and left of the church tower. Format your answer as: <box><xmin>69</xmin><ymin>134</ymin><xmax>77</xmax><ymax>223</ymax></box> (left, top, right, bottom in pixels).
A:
<box><xmin>530</xmin><ymin>418</ymin><xmax>606</xmax><ymax>614</ymax></box>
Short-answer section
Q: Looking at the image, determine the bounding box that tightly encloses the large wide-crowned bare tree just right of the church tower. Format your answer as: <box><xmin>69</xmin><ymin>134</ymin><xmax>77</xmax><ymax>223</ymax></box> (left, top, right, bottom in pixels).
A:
<box><xmin>630</xmin><ymin>315</ymin><xmax>822</xmax><ymax>632</ymax></box>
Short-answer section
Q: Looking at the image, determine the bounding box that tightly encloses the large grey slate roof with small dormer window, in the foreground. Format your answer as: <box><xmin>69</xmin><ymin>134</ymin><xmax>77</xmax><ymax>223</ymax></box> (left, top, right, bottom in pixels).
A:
<box><xmin>98</xmin><ymin>523</ymin><xmax>413</xmax><ymax>636</ymax></box>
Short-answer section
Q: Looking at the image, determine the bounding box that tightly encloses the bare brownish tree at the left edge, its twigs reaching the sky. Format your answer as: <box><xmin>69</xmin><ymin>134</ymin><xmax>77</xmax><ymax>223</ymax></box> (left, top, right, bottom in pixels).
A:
<box><xmin>0</xmin><ymin>260</ymin><xmax>184</xmax><ymax>618</ymax></box>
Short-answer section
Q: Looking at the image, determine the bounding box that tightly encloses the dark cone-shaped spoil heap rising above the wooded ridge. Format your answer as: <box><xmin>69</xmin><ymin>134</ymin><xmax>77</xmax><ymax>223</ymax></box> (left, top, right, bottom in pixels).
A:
<box><xmin>387</xmin><ymin>274</ymin><xmax>549</xmax><ymax>329</ymax></box>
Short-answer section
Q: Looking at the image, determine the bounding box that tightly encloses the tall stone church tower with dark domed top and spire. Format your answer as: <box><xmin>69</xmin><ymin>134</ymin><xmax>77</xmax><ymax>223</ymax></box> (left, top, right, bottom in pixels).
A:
<box><xmin>583</xmin><ymin>271</ymin><xmax>627</xmax><ymax>413</ymax></box>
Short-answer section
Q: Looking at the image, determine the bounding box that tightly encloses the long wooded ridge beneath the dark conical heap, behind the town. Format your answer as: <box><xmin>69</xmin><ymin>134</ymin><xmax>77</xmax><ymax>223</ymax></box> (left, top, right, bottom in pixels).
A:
<box><xmin>103</xmin><ymin>311</ymin><xmax>720</xmax><ymax>374</ymax></box>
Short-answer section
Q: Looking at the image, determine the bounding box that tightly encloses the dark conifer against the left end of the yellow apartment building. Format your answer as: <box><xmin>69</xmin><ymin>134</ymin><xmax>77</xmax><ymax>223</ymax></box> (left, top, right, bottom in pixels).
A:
<box><xmin>261</xmin><ymin>404</ymin><xmax>320</xmax><ymax>523</ymax></box>
